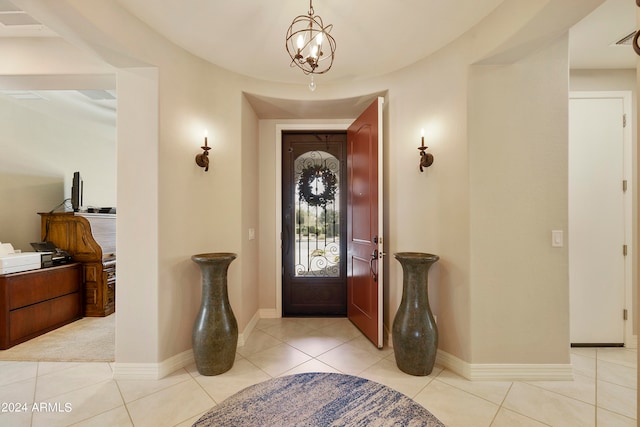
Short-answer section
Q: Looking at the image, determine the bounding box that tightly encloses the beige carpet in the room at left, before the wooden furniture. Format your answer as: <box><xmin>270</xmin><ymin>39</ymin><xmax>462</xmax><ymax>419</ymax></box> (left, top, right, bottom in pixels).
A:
<box><xmin>0</xmin><ymin>314</ymin><xmax>116</xmax><ymax>362</ymax></box>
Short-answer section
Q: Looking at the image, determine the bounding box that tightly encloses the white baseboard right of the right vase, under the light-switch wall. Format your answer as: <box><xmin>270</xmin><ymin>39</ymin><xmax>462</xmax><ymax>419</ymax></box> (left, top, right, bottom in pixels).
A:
<box><xmin>436</xmin><ymin>350</ymin><xmax>573</xmax><ymax>381</ymax></box>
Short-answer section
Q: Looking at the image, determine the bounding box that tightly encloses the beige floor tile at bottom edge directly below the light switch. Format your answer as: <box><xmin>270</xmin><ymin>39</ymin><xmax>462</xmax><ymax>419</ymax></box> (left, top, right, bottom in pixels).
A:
<box><xmin>503</xmin><ymin>383</ymin><xmax>595</xmax><ymax>427</ymax></box>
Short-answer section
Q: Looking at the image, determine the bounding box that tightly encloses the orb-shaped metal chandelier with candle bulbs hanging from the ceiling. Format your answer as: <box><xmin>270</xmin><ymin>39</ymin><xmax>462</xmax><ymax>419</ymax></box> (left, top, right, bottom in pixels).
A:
<box><xmin>286</xmin><ymin>0</ymin><xmax>336</xmax><ymax>89</ymax></box>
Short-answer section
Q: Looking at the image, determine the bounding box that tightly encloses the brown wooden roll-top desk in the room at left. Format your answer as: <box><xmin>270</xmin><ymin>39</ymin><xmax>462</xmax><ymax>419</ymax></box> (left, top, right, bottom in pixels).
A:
<box><xmin>39</xmin><ymin>212</ymin><xmax>116</xmax><ymax>317</ymax></box>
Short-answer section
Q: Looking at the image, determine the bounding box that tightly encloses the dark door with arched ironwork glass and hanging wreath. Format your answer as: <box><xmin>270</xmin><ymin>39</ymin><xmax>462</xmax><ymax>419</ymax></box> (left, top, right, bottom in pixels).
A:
<box><xmin>282</xmin><ymin>131</ymin><xmax>347</xmax><ymax>316</ymax></box>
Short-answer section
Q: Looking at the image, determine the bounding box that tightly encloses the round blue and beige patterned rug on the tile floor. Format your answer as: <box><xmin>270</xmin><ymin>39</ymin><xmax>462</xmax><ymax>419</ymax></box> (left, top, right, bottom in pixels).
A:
<box><xmin>193</xmin><ymin>373</ymin><xmax>444</xmax><ymax>427</ymax></box>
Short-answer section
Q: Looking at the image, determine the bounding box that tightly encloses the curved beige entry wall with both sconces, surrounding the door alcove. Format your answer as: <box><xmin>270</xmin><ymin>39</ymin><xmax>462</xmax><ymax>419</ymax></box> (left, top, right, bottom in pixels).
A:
<box><xmin>3</xmin><ymin>0</ymin><xmax>599</xmax><ymax>374</ymax></box>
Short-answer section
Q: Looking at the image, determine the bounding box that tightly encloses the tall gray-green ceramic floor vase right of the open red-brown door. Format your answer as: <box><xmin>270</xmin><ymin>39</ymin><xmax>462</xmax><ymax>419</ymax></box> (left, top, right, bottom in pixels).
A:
<box><xmin>392</xmin><ymin>252</ymin><xmax>439</xmax><ymax>376</ymax></box>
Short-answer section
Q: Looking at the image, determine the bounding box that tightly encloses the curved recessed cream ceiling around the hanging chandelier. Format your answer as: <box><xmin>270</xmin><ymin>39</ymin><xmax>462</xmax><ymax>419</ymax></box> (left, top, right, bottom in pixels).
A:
<box><xmin>118</xmin><ymin>0</ymin><xmax>503</xmax><ymax>84</ymax></box>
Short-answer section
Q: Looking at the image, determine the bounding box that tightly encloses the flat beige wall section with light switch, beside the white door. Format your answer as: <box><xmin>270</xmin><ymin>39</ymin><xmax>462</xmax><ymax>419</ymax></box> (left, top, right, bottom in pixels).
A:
<box><xmin>468</xmin><ymin>36</ymin><xmax>569</xmax><ymax>363</ymax></box>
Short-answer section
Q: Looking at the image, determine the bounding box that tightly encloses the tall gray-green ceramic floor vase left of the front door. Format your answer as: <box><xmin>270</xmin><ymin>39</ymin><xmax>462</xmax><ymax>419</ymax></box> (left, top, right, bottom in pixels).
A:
<box><xmin>191</xmin><ymin>253</ymin><xmax>238</xmax><ymax>375</ymax></box>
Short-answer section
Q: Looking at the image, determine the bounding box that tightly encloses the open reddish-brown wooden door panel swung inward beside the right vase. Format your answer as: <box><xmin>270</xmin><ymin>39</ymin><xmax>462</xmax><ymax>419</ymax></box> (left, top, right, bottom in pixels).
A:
<box><xmin>347</xmin><ymin>98</ymin><xmax>383</xmax><ymax>348</ymax></box>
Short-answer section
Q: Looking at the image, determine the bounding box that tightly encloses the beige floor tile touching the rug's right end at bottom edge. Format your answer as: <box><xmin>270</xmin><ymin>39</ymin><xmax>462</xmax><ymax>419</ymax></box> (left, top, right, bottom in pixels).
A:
<box><xmin>414</xmin><ymin>379</ymin><xmax>499</xmax><ymax>427</ymax></box>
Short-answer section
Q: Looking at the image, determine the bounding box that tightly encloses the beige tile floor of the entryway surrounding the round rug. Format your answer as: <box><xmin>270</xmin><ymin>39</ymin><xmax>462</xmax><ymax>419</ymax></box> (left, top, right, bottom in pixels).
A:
<box><xmin>0</xmin><ymin>319</ymin><xmax>637</xmax><ymax>427</ymax></box>
